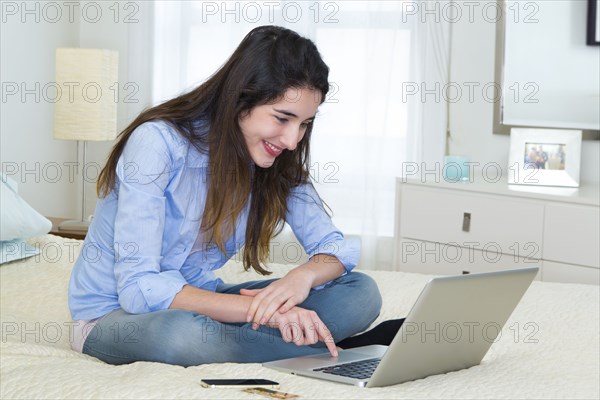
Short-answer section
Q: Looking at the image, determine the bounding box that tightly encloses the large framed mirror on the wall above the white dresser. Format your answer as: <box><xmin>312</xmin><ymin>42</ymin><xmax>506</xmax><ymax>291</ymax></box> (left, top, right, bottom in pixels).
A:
<box><xmin>494</xmin><ymin>0</ymin><xmax>600</xmax><ymax>140</ymax></box>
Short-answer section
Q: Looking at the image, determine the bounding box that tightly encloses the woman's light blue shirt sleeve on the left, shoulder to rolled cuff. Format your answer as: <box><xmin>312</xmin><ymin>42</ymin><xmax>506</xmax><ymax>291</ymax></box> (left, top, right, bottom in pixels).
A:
<box><xmin>114</xmin><ymin>123</ymin><xmax>187</xmax><ymax>314</ymax></box>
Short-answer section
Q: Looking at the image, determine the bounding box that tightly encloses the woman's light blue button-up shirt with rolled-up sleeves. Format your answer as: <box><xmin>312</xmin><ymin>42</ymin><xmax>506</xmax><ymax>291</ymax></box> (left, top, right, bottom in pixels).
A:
<box><xmin>69</xmin><ymin>121</ymin><xmax>360</xmax><ymax>320</ymax></box>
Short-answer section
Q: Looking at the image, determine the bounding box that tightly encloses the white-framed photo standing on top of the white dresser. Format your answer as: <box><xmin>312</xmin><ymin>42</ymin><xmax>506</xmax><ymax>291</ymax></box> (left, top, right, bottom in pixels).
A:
<box><xmin>508</xmin><ymin>128</ymin><xmax>581</xmax><ymax>187</ymax></box>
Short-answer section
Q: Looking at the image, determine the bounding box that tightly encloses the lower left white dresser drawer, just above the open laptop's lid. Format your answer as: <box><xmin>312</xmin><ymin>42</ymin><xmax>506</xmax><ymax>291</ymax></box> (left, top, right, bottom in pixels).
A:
<box><xmin>396</xmin><ymin>238</ymin><xmax>542</xmax><ymax>280</ymax></box>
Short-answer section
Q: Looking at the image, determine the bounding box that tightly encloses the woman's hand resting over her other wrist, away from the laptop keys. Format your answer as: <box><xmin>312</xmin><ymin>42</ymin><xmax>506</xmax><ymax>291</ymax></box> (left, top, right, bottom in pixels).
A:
<box><xmin>240</xmin><ymin>268</ymin><xmax>314</xmax><ymax>329</ymax></box>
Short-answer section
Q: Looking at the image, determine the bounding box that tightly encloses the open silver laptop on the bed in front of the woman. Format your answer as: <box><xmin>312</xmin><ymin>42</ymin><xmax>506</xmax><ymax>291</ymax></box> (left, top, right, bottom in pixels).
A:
<box><xmin>263</xmin><ymin>267</ymin><xmax>539</xmax><ymax>387</ymax></box>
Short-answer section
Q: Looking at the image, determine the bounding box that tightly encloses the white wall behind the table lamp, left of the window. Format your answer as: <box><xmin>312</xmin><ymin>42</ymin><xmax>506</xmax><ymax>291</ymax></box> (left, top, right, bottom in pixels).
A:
<box><xmin>0</xmin><ymin>1</ymin><xmax>152</xmax><ymax>218</ymax></box>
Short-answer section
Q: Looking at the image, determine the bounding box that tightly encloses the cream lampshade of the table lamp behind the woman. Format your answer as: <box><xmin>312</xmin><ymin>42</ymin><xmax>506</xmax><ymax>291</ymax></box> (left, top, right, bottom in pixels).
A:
<box><xmin>54</xmin><ymin>48</ymin><xmax>119</xmax><ymax>140</ymax></box>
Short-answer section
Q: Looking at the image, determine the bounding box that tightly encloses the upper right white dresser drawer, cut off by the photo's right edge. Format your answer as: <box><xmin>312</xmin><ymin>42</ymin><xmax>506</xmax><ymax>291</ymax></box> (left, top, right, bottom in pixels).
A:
<box><xmin>543</xmin><ymin>204</ymin><xmax>600</xmax><ymax>268</ymax></box>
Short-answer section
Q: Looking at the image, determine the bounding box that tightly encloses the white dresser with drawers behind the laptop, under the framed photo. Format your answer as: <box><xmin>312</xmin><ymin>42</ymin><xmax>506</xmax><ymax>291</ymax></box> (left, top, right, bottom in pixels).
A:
<box><xmin>393</xmin><ymin>178</ymin><xmax>600</xmax><ymax>285</ymax></box>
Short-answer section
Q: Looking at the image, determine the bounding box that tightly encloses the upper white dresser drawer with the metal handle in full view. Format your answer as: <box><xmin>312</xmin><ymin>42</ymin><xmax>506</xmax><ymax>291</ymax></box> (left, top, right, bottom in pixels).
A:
<box><xmin>399</xmin><ymin>185</ymin><xmax>544</xmax><ymax>259</ymax></box>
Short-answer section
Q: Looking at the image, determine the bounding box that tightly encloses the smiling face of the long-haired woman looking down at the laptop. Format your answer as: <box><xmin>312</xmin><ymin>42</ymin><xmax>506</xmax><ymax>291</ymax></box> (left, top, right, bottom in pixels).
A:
<box><xmin>239</xmin><ymin>88</ymin><xmax>321</xmax><ymax>168</ymax></box>
